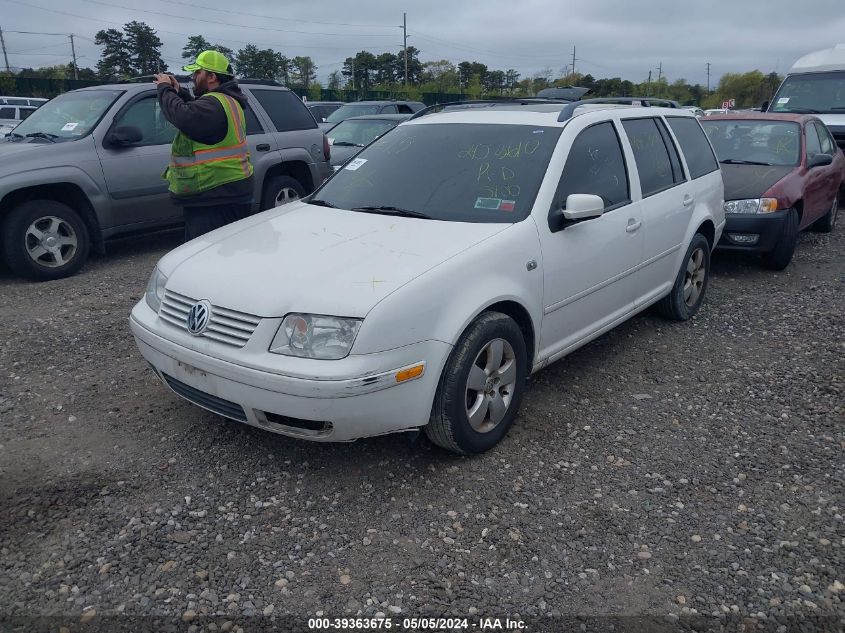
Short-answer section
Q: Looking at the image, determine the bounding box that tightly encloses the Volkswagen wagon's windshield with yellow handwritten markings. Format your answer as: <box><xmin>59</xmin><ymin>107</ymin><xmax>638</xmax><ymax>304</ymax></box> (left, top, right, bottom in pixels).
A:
<box><xmin>311</xmin><ymin>123</ymin><xmax>561</xmax><ymax>223</ymax></box>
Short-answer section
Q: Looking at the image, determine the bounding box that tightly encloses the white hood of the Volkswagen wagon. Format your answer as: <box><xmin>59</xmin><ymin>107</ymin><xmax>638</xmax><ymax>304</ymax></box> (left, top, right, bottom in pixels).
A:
<box><xmin>161</xmin><ymin>202</ymin><xmax>511</xmax><ymax>317</ymax></box>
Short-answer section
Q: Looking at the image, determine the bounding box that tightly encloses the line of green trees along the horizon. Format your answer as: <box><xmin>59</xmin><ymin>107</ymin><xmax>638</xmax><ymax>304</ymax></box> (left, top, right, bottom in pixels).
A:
<box><xmin>0</xmin><ymin>20</ymin><xmax>782</xmax><ymax>108</ymax></box>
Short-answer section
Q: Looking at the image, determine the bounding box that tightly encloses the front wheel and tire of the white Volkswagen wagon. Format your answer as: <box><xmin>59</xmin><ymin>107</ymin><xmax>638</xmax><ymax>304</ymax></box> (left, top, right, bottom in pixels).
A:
<box><xmin>425</xmin><ymin>312</ymin><xmax>528</xmax><ymax>455</ymax></box>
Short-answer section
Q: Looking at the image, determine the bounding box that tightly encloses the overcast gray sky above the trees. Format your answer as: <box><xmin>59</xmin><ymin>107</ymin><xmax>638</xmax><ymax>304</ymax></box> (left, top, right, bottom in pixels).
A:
<box><xmin>0</xmin><ymin>0</ymin><xmax>845</xmax><ymax>85</ymax></box>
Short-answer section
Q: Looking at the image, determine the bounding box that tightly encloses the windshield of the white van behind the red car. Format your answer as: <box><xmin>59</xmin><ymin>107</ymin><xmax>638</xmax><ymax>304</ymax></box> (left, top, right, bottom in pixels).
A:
<box><xmin>769</xmin><ymin>70</ymin><xmax>845</xmax><ymax>114</ymax></box>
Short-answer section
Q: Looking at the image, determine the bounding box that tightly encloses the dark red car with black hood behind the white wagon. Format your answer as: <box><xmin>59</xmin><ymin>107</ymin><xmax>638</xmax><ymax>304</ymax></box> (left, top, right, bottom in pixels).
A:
<box><xmin>701</xmin><ymin>112</ymin><xmax>845</xmax><ymax>270</ymax></box>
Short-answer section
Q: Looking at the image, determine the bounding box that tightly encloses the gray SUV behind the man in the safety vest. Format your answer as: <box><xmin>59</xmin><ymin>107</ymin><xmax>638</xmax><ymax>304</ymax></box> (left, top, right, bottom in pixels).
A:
<box><xmin>0</xmin><ymin>82</ymin><xmax>331</xmax><ymax>280</ymax></box>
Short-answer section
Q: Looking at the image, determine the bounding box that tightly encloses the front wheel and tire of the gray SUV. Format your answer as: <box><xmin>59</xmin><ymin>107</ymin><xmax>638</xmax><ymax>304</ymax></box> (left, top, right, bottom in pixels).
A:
<box><xmin>3</xmin><ymin>200</ymin><xmax>91</xmax><ymax>281</ymax></box>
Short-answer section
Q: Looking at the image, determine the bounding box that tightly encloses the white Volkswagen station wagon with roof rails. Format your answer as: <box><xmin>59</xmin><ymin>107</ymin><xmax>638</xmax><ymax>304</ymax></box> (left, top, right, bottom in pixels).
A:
<box><xmin>131</xmin><ymin>103</ymin><xmax>725</xmax><ymax>453</ymax></box>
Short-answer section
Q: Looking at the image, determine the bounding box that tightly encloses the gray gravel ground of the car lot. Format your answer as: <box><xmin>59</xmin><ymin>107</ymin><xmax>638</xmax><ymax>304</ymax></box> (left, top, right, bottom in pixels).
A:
<box><xmin>0</xmin><ymin>218</ymin><xmax>845</xmax><ymax>631</ymax></box>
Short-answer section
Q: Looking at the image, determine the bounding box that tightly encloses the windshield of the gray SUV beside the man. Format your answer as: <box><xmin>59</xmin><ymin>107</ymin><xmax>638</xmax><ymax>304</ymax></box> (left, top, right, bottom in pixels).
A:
<box><xmin>14</xmin><ymin>90</ymin><xmax>123</xmax><ymax>141</ymax></box>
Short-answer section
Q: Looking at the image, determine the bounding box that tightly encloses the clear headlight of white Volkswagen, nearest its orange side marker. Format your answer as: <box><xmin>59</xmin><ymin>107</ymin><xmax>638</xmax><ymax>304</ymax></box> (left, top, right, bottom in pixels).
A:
<box><xmin>270</xmin><ymin>313</ymin><xmax>361</xmax><ymax>360</ymax></box>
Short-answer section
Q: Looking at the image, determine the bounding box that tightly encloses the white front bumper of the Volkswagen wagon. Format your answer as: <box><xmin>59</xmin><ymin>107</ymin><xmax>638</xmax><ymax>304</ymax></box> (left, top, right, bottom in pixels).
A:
<box><xmin>129</xmin><ymin>299</ymin><xmax>451</xmax><ymax>442</ymax></box>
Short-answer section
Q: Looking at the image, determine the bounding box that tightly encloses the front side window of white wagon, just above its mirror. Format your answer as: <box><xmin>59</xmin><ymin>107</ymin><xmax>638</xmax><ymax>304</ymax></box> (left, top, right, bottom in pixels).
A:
<box><xmin>552</xmin><ymin>122</ymin><xmax>630</xmax><ymax>209</ymax></box>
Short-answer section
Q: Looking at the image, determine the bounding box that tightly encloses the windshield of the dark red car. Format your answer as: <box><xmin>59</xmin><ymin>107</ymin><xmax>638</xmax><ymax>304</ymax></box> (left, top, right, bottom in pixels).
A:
<box><xmin>701</xmin><ymin>119</ymin><xmax>801</xmax><ymax>165</ymax></box>
